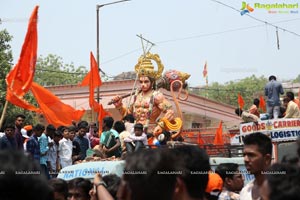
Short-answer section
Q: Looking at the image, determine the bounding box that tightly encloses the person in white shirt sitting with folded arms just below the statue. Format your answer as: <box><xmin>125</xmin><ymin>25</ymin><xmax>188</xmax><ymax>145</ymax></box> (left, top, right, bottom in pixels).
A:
<box><xmin>124</xmin><ymin>123</ymin><xmax>148</xmax><ymax>153</ymax></box>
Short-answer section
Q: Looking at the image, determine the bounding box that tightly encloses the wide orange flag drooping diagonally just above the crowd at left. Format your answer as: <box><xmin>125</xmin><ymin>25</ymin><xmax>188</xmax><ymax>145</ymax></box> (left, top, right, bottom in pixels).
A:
<box><xmin>31</xmin><ymin>82</ymin><xmax>85</xmax><ymax>127</ymax></box>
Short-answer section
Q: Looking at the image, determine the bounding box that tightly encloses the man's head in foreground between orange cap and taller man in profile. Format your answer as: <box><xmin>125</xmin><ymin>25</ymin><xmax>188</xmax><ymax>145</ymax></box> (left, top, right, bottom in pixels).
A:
<box><xmin>215</xmin><ymin>163</ymin><xmax>244</xmax><ymax>200</ymax></box>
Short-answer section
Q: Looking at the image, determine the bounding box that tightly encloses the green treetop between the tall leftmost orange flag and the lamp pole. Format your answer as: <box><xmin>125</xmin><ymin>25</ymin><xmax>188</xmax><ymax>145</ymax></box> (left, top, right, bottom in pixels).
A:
<box><xmin>34</xmin><ymin>54</ymin><xmax>87</xmax><ymax>86</ymax></box>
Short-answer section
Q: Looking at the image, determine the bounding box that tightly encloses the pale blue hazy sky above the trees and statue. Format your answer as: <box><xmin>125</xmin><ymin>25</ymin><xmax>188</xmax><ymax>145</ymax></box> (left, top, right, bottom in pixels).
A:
<box><xmin>0</xmin><ymin>0</ymin><xmax>300</xmax><ymax>86</ymax></box>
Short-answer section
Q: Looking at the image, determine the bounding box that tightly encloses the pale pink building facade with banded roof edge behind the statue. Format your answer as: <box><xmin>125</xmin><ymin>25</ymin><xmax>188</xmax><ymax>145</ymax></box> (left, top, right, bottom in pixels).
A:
<box><xmin>47</xmin><ymin>80</ymin><xmax>241</xmax><ymax>132</ymax></box>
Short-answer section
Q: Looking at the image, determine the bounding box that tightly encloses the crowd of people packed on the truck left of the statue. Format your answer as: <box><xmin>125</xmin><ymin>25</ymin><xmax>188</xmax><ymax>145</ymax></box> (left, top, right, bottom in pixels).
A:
<box><xmin>0</xmin><ymin>114</ymin><xmax>154</xmax><ymax>179</ymax></box>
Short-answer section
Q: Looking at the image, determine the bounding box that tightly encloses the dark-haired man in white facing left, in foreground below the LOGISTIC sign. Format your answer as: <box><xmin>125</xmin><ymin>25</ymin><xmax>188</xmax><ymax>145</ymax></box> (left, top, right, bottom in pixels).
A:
<box><xmin>240</xmin><ymin>132</ymin><xmax>272</xmax><ymax>200</ymax></box>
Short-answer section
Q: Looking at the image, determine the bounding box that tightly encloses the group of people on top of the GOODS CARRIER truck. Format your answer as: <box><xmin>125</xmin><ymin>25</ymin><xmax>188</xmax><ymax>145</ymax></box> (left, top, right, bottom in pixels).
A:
<box><xmin>235</xmin><ymin>75</ymin><xmax>300</xmax><ymax>122</ymax></box>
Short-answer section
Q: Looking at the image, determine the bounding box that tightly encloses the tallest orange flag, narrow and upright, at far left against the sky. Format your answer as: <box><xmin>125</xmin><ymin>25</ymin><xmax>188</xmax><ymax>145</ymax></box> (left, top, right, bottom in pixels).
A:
<box><xmin>6</xmin><ymin>6</ymin><xmax>39</xmax><ymax>97</ymax></box>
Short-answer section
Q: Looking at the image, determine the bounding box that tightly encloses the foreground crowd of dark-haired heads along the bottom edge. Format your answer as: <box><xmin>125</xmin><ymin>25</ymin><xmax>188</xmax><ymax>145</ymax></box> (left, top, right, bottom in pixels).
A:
<box><xmin>0</xmin><ymin>132</ymin><xmax>300</xmax><ymax>200</ymax></box>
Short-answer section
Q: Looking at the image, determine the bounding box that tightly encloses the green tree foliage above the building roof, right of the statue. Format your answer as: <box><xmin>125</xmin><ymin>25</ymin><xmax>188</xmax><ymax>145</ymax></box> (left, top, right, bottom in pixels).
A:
<box><xmin>196</xmin><ymin>75</ymin><xmax>268</xmax><ymax>109</ymax></box>
